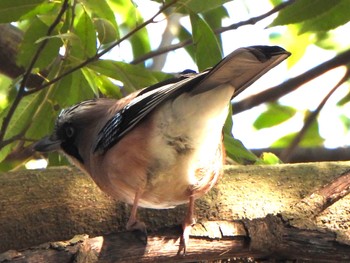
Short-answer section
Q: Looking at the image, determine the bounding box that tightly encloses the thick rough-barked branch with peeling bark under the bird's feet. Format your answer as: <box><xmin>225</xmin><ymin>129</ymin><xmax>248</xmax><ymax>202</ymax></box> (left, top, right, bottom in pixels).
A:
<box><xmin>0</xmin><ymin>162</ymin><xmax>350</xmax><ymax>262</ymax></box>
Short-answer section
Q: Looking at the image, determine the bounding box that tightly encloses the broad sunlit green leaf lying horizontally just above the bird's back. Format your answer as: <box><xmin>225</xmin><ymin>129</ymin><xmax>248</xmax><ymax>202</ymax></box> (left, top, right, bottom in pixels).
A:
<box><xmin>88</xmin><ymin>60</ymin><xmax>168</xmax><ymax>93</ymax></box>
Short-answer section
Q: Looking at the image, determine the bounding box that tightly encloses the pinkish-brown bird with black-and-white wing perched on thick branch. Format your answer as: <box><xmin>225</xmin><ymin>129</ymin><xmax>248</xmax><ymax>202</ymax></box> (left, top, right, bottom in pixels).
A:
<box><xmin>33</xmin><ymin>46</ymin><xmax>291</xmax><ymax>254</ymax></box>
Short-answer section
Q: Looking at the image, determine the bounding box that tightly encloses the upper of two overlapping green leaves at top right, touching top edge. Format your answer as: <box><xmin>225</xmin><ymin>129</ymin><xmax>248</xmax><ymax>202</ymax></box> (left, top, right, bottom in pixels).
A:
<box><xmin>271</xmin><ymin>0</ymin><xmax>341</xmax><ymax>26</ymax></box>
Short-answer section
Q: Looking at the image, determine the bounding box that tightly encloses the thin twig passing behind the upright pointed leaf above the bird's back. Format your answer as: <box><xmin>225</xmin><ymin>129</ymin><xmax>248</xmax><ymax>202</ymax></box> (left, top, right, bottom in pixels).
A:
<box><xmin>130</xmin><ymin>0</ymin><xmax>295</xmax><ymax>65</ymax></box>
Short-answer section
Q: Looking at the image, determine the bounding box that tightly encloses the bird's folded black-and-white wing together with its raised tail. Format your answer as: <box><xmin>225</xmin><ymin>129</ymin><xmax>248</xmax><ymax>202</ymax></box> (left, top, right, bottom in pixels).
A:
<box><xmin>93</xmin><ymin>46</ymin><xmax>290</xmax><ymax>154</ymax></box>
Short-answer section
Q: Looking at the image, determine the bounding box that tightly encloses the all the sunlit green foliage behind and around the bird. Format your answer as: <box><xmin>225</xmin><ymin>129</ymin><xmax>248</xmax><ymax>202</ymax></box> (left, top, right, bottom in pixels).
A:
<box><xmin>0</xmin><ymin>0</ymin><xmax>350</xmax><ymax>170</ymax></box>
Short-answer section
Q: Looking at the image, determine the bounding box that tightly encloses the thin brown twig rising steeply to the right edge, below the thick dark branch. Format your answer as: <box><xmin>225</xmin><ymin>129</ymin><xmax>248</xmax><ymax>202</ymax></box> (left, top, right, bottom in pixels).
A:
<box><xmin>280</xmin><ymin>68</ymin><xmax>350</xmax><ymax>162</ymax></box>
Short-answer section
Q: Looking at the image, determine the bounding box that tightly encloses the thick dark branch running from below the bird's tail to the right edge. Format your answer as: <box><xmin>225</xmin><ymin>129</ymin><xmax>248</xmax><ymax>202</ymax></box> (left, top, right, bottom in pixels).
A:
<box><xmin>232</xmin><ymin>49</ymin><xmax>350</xmax><ymax>114</ymax></box>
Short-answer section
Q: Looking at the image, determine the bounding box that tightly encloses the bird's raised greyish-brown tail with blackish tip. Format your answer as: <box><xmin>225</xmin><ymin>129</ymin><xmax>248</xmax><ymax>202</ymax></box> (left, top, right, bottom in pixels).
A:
<box><xmin>191</xmin><ymin>46</ymin><xmax>291</xmax><ymax>97</ymax></box>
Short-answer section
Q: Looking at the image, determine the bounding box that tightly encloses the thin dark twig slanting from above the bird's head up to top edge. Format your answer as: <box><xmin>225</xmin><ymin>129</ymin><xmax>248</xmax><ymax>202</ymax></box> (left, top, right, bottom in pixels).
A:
<box><xmin>25</xmin><ymin>0</ymin><xmax>177</xmax><ymax>95</ymax></box>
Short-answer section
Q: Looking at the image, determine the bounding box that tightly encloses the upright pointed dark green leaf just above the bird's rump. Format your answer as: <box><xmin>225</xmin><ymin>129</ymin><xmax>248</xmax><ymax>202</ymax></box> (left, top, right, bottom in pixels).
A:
<box><xmin>190</xmin><ymin>13</ymin><xmax>222</xmax><ymax>71</ymax></box>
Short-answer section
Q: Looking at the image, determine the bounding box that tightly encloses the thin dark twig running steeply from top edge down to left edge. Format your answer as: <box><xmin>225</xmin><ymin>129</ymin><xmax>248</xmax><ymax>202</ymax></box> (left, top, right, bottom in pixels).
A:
<box><xmin>0</xmin><ymin>0</ymin><xmax>68</xmax><ymax>148</ymax></box>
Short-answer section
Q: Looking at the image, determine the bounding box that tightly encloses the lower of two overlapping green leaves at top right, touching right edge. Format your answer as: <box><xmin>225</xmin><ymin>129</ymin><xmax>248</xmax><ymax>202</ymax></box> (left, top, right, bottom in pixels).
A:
<box><xmin>299</xmin><ymin>0</ymin><xmax>350</xmax><ymax>34</ymax></box>
